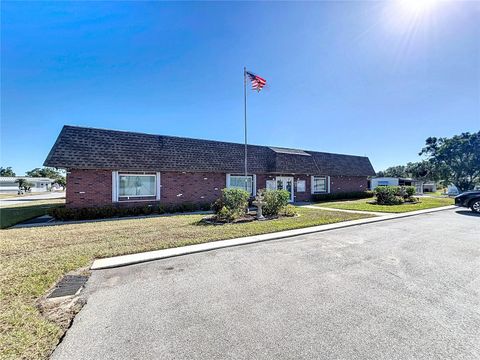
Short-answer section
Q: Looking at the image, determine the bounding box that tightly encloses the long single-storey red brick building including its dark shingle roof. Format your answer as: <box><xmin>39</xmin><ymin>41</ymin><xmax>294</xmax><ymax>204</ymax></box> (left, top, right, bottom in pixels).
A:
<box><xmin>44</xmin><ymin>126</ymin><xmax>375</xmax><ymax>207</ymax></box>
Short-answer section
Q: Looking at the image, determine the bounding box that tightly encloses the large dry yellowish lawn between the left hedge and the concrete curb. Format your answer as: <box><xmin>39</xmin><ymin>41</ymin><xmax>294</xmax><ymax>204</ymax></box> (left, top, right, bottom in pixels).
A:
<box><xmin>0</xmin><ymin>208</ymin><xmax>369</xmax><ymax>359</ymax></box>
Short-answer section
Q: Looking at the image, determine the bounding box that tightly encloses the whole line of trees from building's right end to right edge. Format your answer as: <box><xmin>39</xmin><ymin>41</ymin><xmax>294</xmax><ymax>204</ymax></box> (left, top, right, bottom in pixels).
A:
<box><xmin>377</xmin><ymin>131</ymin><xmax>480</xmax><ymax>192</ymax></box>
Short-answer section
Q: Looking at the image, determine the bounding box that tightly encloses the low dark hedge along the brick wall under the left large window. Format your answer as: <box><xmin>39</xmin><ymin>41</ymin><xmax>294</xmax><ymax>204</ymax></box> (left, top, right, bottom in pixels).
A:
<box><xmin>48</xmin><ymin>203</ymin><xmax>210</xmax><ymax>221</ymax></box>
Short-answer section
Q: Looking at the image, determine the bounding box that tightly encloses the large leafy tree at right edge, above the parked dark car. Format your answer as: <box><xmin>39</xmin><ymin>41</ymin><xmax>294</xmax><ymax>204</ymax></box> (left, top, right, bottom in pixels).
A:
<box><xmin>419</xmin><ymin>131</ymin><xmax>480</xmax><ymax>192</ymax></box>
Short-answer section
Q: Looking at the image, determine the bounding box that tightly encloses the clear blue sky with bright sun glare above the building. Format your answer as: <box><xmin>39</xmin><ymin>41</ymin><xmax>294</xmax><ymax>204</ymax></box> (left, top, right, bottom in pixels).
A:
<box><xmin>0</xmin><ymin>0</ymin><xmax>480</xmax><ymax>174</ymax></box>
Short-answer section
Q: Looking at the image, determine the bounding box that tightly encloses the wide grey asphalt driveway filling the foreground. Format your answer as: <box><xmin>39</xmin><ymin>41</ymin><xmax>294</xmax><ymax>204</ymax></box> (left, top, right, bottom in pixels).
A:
<box><xmin>53</xmin><ymin>210</ymin><xmax>480</xmax><ymax>360</ymax></box>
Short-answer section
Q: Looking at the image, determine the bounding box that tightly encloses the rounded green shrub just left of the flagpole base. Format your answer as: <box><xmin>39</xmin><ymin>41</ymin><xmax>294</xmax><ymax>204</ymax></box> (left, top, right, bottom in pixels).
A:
<box><xmin>212</xmin><ymin>189</ymin><xmax>250</xmax><ymax>222</ymax></box>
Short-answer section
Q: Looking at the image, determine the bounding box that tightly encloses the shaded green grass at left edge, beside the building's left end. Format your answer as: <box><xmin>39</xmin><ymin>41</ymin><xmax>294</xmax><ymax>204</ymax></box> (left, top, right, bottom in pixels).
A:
<box><xmin>0</xmin><ymin>199</ymin><xmax>65</xmax><ymax>229</ymax></box>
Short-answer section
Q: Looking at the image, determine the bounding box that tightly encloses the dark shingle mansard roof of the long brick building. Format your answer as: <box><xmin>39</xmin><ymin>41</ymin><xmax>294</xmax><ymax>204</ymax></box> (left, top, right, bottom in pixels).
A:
<box><xmin>44</xmin><ymin>126</ymin><xmax>375</xmax><ymax>176</ymax></box>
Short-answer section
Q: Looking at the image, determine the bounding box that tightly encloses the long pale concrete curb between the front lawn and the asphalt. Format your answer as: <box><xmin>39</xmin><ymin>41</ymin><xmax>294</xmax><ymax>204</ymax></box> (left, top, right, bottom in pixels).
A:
<box><xmin>90</xmin><ymin>205</ymin><xmax>456</xmax><ymax>270</ymax></box>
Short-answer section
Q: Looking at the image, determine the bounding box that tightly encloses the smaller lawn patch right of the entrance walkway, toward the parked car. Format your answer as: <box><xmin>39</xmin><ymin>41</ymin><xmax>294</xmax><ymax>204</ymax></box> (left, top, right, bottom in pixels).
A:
<box><xmin>316</xmin><ymin>197</ymin><xmax>454</xmax><ymax>213</ymax></box>
